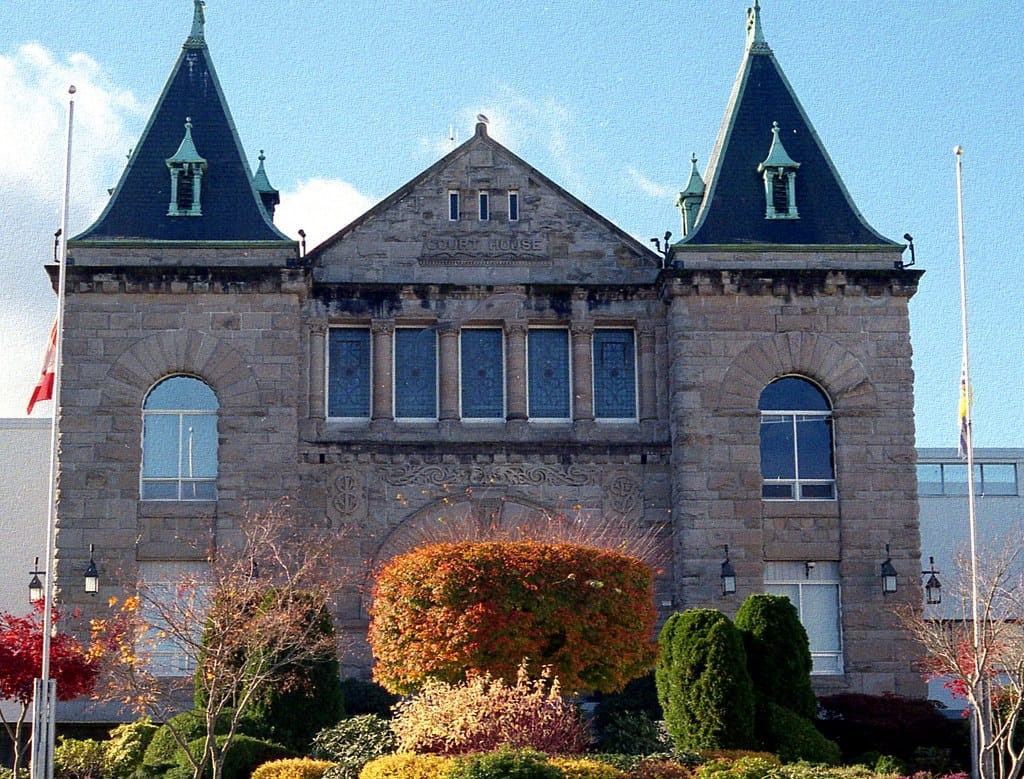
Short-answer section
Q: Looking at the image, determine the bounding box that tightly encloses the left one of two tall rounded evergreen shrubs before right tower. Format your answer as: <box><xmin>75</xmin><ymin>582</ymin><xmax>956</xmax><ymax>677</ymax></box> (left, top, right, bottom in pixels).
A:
<box><xmin>654</xmin><ymin>609</ymin><xmax>757</xmax><ymax>750</ymax></box>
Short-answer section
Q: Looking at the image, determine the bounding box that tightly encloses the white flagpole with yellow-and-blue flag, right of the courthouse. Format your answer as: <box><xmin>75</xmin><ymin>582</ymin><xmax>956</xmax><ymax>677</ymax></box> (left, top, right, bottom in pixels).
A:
<box><xmin>953</xmin><ymin>146</ymin><xmax>992</xmax><ymax>779</ymax></box>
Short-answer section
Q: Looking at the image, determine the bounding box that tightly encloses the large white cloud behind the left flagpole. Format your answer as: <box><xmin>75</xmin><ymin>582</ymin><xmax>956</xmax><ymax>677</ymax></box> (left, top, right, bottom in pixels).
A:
<box><xmin>0</xmin><ymin>44</ymin><xmax>146</xmax><ymax>417</ymax></box>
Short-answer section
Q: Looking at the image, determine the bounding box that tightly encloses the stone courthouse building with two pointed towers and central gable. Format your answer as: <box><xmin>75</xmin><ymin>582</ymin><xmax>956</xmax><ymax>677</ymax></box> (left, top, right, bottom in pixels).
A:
<box><xmin>51</xmin><ymin>3</ymin><xmax>924</xmax><ymax>695</ymax></box>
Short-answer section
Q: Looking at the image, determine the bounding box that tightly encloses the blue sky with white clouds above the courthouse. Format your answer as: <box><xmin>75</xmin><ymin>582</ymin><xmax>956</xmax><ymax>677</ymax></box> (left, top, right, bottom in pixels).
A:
<box><xmin>0</xmin><ymin>0</ymin><xmax>1024</xmax><ymax>446</ymax></box>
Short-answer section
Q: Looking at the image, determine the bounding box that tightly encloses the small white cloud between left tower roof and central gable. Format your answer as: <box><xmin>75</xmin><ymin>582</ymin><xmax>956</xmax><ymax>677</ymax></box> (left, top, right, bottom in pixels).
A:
<box><xmin>273</xmin><ymin>178</ymin><xmax>377</xmax><ymax>249</ymax></box>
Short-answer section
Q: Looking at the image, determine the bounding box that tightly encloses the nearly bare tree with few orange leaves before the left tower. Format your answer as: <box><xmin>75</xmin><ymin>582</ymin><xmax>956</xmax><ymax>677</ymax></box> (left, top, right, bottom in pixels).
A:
<box><xmin>93</xmin><ymin>509</ymin><xmax>339</xmax><ymax>779</ymax></box>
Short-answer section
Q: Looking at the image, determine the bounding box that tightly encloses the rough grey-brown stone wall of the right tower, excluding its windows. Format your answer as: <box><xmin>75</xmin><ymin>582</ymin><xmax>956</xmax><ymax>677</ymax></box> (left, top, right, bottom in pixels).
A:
<box><xmin>669</xmin><ymin>272</ymin><xmax>923</xmax><ymax>695</ymax></box>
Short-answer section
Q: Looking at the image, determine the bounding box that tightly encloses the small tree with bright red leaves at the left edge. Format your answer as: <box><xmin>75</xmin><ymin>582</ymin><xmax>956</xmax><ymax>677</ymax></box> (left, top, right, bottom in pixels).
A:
<box><xmin>0</xmin><ymin>602</ymin><xmax>99</xmax><ymax>776</ymax></box>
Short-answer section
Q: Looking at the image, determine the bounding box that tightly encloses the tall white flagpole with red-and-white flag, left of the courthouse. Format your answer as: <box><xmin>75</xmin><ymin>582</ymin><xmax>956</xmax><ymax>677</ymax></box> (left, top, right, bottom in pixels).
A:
<box><xmin>32</xmin><ymin>85</ymin><xmax>76</xmax><ymax>779</ymax></box>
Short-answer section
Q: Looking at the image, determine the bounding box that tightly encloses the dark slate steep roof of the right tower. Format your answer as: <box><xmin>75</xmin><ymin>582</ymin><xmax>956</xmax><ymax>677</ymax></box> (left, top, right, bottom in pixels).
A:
<box><xmin>677</xmin><ymin>12</ymin><xmax>895</xmax><ymax>247</ymax></box>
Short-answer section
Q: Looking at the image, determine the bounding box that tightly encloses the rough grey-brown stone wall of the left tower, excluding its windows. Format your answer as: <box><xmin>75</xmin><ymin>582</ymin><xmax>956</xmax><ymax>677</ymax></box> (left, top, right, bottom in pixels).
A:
<box><xmin>57</xmin><ymin>273</ymin><xmax>305</xmax><ymax>620</ymax></box>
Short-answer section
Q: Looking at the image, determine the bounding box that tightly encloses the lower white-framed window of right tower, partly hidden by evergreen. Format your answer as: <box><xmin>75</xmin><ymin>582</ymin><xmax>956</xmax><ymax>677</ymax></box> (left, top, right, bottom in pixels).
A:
<box><xmin>765</xmin><ymin>561</ymin><xmax>843</xmax><ymax>676</ymax></box>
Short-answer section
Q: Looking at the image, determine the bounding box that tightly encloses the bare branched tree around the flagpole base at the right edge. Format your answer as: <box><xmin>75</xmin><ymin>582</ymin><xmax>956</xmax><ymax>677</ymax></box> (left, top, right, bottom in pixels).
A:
<box><xmin>901</xmin><ymin>538</ymin><xmax>1024</xmax><ymax>779</ymax></box>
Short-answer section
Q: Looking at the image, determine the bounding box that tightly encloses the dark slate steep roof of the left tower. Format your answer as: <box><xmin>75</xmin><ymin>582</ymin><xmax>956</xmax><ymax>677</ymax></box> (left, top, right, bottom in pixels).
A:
<box><xmin>76</xmin><ymin>31</ymin><xmax>290</xmax><ymax>242</ymax></box>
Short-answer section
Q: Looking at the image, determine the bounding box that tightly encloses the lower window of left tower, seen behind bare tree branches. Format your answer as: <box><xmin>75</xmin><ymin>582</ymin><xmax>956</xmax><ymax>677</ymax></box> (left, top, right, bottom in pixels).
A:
<box><xmin>135</xmin><ymin>560</ymin><xmax>210</xmax><ymax>678</ymax></box>
